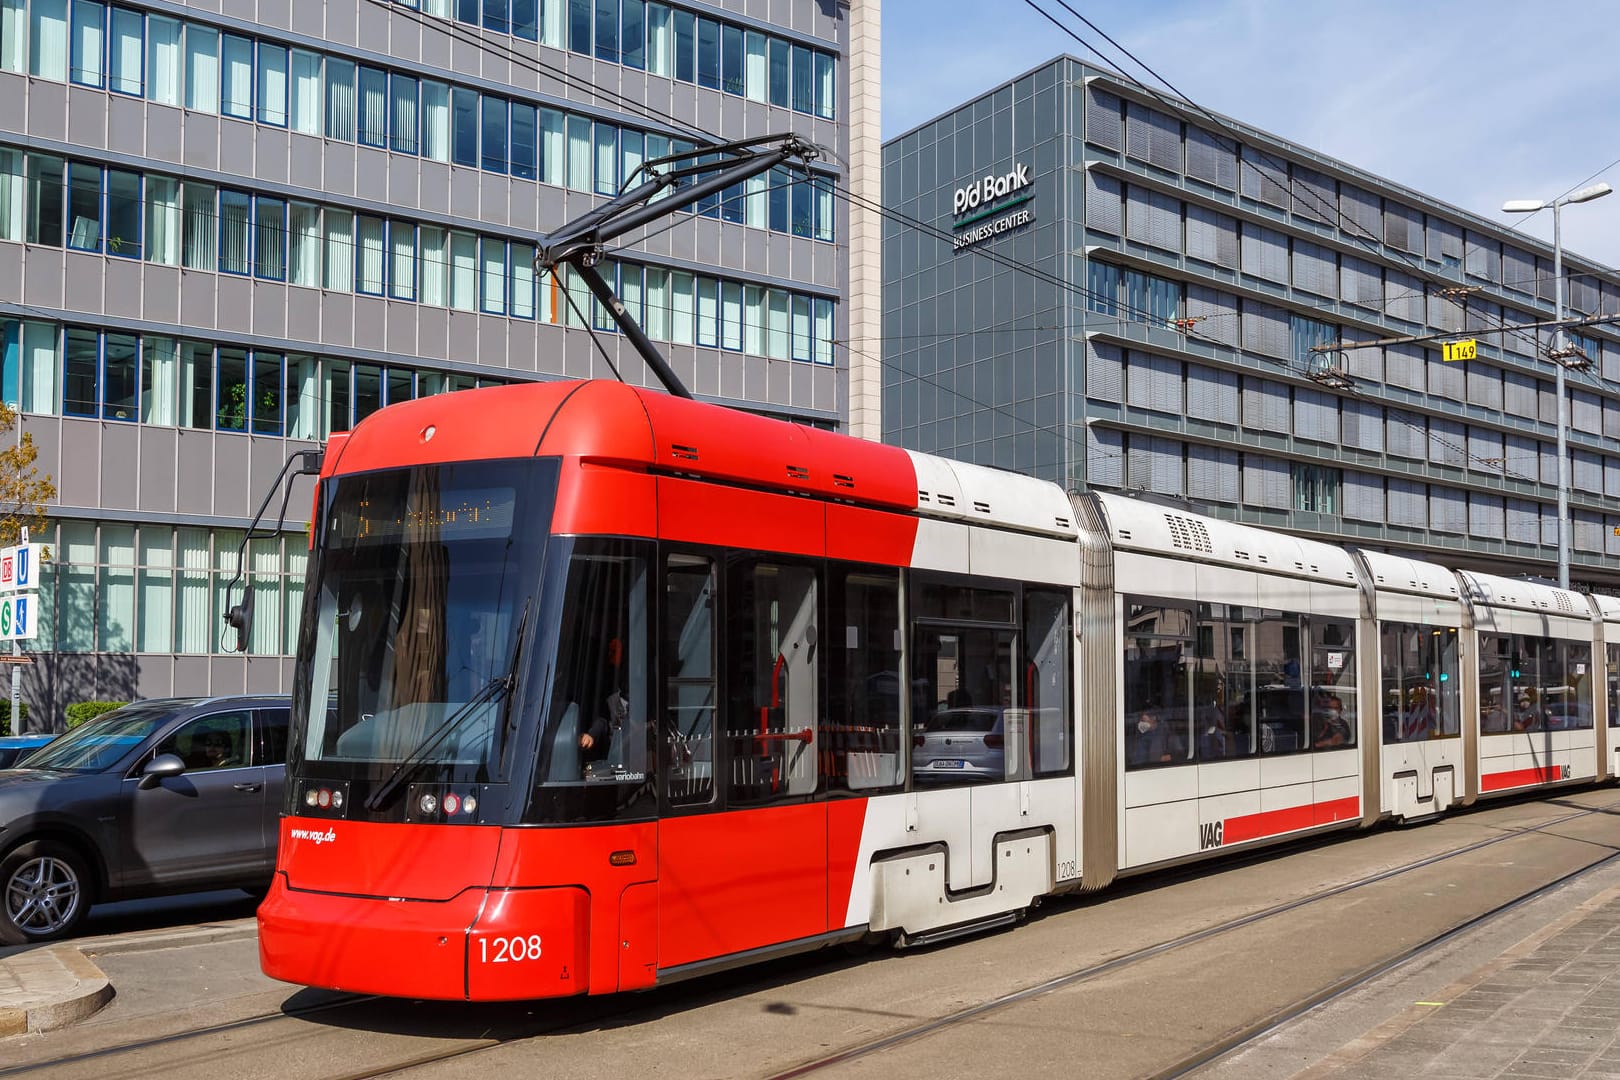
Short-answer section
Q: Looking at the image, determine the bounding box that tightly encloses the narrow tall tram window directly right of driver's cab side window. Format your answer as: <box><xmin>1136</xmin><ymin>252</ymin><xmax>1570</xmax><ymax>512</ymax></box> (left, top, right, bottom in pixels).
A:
<box><xmin>663</xmin><ymin>555</ymin><xmax>714</xmax><ymax>806</ymax></box>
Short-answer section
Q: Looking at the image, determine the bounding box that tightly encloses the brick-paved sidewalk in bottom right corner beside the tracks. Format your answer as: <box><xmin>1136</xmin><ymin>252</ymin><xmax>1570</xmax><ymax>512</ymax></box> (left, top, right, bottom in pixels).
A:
<box><xmin>1299</xmin><ymin>887</ymin><xmax>1620</xmax><ymax>1080</ymax></box>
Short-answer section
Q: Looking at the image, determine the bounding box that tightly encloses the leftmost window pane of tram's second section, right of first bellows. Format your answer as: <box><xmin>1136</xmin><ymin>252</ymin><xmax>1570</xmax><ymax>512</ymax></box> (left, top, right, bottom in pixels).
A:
<box><xmin>1123</xmin><ymin>597</ymin><xmax>1199</xmax><ymax>769</ymax></box>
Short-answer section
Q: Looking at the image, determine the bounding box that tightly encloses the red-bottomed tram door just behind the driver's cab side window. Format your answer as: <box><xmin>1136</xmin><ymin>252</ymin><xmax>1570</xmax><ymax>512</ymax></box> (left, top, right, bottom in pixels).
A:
<box><xmin>658</xmin><ymin>554</ymin><xmax>826</xmax><ymax>968</ymax></box>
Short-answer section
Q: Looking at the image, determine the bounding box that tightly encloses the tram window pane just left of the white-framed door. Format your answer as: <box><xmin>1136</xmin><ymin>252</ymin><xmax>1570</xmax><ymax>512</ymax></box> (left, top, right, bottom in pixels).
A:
<box><xmin>818</xmin><ymin>570</ymin><xmax>906</xmax><ymax>792</ymax></box>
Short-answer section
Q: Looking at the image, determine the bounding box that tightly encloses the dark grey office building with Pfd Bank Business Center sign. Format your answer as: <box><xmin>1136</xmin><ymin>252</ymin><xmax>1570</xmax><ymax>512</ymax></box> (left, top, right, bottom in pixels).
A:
<box><xmin>883</xmin><ymin>58</ymin><xmax>1620</xmax><ymax>589</ymax></box>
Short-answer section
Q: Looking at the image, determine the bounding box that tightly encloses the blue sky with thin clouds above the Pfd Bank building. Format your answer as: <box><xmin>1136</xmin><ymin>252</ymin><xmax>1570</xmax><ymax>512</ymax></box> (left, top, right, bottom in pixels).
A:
<box><xmin>883</xmin><ymin>0</ymin><xmax>1620</xmax><ymax>267</ymax></box>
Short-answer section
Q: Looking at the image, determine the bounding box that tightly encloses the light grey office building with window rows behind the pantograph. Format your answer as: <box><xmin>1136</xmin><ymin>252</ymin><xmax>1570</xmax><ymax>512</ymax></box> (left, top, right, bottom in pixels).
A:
<box><xmin>0</xmin><ymin>0</ymin><xmax>878</xmax><ymax>725</ymax></box>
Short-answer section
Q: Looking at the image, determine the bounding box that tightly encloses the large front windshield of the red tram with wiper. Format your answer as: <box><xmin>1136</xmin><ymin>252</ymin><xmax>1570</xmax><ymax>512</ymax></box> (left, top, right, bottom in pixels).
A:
<box><xmin>292</xmin><ymin>458</ymin><xmax>557</xmax><ymax>803</ymax></box>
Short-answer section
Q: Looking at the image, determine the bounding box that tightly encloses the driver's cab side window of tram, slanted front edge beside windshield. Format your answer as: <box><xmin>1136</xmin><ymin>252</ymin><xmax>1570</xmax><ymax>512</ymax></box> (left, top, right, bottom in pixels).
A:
<box><xmin>536</xmin><ymin>541</ymin><xmax>650</xmax><ymax>819</ymax></box>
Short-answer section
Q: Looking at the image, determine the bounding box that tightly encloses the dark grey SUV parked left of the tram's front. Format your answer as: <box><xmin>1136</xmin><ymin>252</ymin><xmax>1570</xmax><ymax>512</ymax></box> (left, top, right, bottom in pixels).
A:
<box><xmin>0</xmin><ymin>696</ymin><xmax>288</xmax><ymax>944</ymax></box>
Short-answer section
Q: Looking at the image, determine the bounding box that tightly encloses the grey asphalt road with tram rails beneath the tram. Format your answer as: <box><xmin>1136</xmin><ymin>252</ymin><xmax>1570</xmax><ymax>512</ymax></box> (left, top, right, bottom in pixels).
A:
<box><xmin>0</xmin><ymin>789</ymin><xmax>1620</xmax><ymax>1080</ymax></box>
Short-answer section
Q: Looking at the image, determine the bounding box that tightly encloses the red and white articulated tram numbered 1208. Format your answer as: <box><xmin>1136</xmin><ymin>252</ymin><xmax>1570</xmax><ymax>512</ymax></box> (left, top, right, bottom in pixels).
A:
<box><xmin>259</xmin><ymin>375</ymin><xmax>1620</xmax><ymax>1001</ymax></box>
